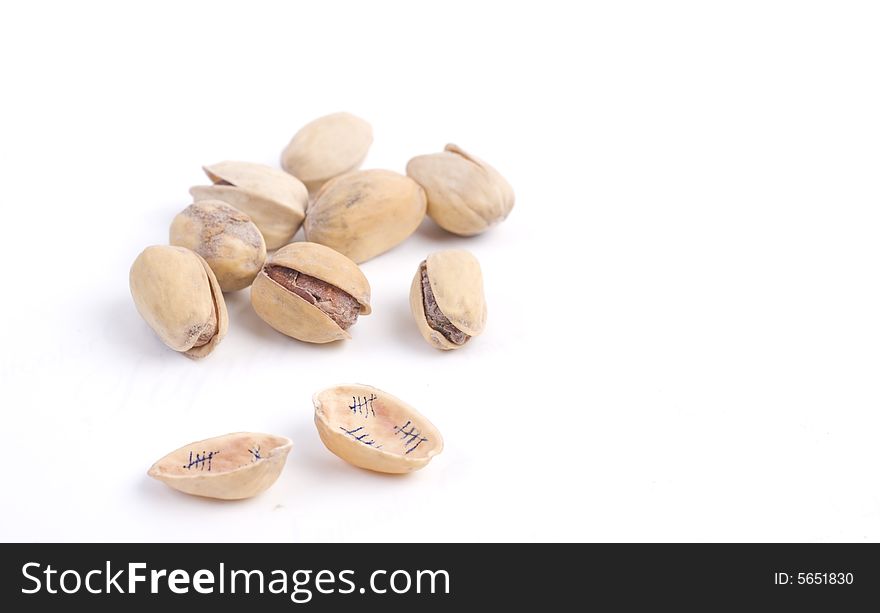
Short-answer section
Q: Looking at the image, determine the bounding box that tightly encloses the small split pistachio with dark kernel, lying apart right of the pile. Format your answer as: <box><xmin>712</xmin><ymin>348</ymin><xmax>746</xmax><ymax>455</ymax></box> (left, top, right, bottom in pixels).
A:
<box><xmin>409</xmin><ymin>249</ymin><xmax>486</xmax><ymax>350</ymax></box>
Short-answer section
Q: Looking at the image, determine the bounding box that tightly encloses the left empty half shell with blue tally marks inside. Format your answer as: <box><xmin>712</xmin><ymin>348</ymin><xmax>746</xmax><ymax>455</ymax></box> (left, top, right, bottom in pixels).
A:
<box><xmin>147</xmin><ymin>432</ymin><xmax>293</xmax><ymax>500</ymax></box>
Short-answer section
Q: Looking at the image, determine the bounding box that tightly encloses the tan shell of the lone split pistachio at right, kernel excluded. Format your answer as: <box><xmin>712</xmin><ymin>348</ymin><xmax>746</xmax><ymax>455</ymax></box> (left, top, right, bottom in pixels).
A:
<box><xmin>410</xmin><ymin>249</ymin><xmax>487</xmax><ymax>350</ymax></box>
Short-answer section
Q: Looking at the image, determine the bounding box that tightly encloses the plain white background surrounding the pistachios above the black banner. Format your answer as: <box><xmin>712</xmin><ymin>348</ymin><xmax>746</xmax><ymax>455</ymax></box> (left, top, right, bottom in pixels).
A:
<box><xmin>0</xmin><ymin>1</ymin><xmax>880</xmax><ymax>542</ymax></box>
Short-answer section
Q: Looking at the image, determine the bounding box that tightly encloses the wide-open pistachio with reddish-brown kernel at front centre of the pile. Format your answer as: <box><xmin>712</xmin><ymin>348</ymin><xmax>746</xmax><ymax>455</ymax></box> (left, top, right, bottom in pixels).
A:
<box><xmin>251</xmin><ymin>242</ymin><xmax>370</xmax><ymax>343</ymax></box>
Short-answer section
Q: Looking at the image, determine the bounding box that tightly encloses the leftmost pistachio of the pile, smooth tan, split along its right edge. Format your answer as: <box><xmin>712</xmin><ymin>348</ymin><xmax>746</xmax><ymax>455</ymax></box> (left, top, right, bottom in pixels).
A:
<box><xmin>129</xmin><ymin>245</ymin><xmax>229</xmax><ymax>358</ymax></box>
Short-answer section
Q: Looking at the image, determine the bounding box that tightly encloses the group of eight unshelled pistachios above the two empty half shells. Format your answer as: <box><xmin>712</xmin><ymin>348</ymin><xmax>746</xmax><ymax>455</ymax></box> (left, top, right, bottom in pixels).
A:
<box><xmin>129</xmin><ymin>113</ymin><xmax>514</xmax><ymax>358</ymax></box>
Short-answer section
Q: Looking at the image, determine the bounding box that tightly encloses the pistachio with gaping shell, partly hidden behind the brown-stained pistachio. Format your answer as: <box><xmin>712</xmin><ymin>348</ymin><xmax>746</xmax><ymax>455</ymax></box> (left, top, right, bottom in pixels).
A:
<box><xmin>189</xmin><ymin>162</ymin><xmax>309</xmax><ymax>249</ymax></box>
